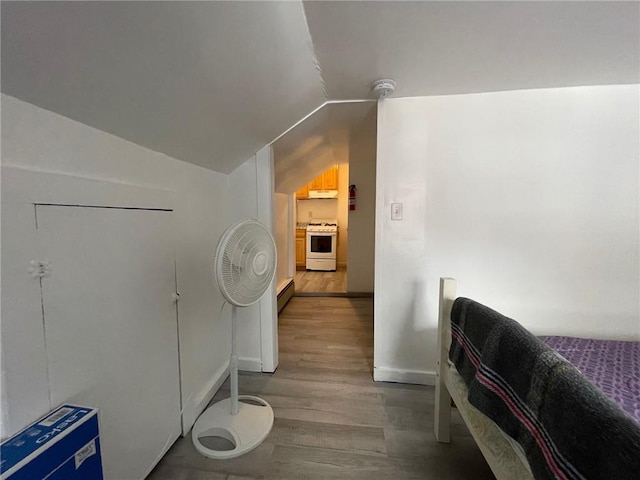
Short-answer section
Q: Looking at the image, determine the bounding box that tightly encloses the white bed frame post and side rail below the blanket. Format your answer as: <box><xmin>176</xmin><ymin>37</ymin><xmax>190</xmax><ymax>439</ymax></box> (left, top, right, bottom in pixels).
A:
<box><xmin>434</xmin><ymin>278</ymin><xmax>534</xmax><ymax>480</ymax></box>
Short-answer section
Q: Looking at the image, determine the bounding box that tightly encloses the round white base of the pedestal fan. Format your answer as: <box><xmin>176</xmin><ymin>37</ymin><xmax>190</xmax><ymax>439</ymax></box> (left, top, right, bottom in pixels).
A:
<box><xmin>191</xmin><ymin>395</ymin><xmax>273</xmax><ymax>460</ymax></box>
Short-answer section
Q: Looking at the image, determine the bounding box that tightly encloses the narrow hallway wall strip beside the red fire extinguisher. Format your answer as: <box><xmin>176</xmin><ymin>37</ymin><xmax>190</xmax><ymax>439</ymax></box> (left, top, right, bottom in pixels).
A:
<box><xmin>347</xmin><ymin>109</ymin><xmax>377</xmax><ymax>292</ymax></box>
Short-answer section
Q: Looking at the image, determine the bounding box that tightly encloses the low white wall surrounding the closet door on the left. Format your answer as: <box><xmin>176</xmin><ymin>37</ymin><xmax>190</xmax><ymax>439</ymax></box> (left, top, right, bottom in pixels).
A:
<box><xmin>1</xmin><ymin>95</ymin><xmax>235</xmax><ymax>437</ymax></box>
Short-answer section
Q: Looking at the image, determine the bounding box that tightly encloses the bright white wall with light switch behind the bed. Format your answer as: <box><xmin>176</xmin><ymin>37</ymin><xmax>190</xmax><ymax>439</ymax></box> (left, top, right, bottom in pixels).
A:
<box><xmin>376</xmin><ymin>85</ymin><xmax>640</xmax><ymax>383</ymax></box>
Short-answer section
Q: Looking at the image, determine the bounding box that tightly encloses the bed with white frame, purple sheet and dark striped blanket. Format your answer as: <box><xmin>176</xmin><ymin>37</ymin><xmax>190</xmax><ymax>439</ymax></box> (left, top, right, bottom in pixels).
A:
<box><xmin>434</xmin><ymin>278</ymin><xmax>640</xmax><ymax>480</ymax></box>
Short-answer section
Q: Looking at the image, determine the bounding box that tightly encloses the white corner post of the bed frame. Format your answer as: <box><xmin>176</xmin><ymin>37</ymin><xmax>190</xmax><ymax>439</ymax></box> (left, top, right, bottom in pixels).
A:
<box><xmin>433</xmin><ymin>278</ymin><xmax>456</xmax><ymax>443</ymax></box>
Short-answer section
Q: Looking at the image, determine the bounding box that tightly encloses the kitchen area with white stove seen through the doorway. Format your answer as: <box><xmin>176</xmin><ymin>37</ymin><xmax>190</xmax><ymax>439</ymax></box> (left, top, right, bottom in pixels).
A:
<box><xmin>272</xmin><ymin>102</ymin><xmax>377</xmax><ymax>309</ymax></box>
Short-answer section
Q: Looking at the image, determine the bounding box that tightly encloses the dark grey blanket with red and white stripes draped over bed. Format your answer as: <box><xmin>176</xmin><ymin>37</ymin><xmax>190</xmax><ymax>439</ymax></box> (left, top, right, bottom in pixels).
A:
<box><xmin>449</xmin><ymin>297</ymin><xmax>640</xmax><ymax>480</ymax></box>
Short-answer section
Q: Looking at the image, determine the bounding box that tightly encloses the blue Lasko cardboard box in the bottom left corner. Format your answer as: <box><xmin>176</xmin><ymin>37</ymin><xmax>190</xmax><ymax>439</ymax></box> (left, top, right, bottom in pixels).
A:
<box><xmin>0</xmin><ymin>405</ymin><xmax>103</xmax><ymax>480</ymax></box>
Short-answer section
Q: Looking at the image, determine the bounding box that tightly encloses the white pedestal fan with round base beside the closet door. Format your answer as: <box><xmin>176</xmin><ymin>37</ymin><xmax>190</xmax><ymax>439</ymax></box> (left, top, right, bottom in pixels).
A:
<box><xmin>191</xmin><ymin>220</ymin><xmax>276</xmax><ymax>459</ymax></box>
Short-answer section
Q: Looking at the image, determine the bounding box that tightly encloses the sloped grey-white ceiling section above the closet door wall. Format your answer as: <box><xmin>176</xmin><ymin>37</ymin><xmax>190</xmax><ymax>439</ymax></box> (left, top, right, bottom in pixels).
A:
<box><xmin>2</xmin><ymin>1</ymin><xmax>325</xmax><ymax>173</ymax></box>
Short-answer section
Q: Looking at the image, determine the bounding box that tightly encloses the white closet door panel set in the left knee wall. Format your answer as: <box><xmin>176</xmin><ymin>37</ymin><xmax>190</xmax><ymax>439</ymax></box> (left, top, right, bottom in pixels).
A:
<box><xmin>36</xmin><ymin>206</ymin><xmax>180</xmax><ymax>480</ymax></box>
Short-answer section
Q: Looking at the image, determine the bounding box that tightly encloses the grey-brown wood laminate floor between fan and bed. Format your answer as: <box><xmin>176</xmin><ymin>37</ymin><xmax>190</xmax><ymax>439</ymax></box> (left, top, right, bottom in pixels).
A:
<box><xmin>148</xmin><ymin>297</ymin><xmax>494</xmax><ymax>480</ymax></box>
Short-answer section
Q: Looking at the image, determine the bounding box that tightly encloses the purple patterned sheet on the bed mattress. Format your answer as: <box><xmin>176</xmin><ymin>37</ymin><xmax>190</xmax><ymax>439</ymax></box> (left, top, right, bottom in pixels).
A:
<box><xmin>540</xmin><ymin>337</ymin><xmax>640</xmax><ymax>424</ymax></box>
